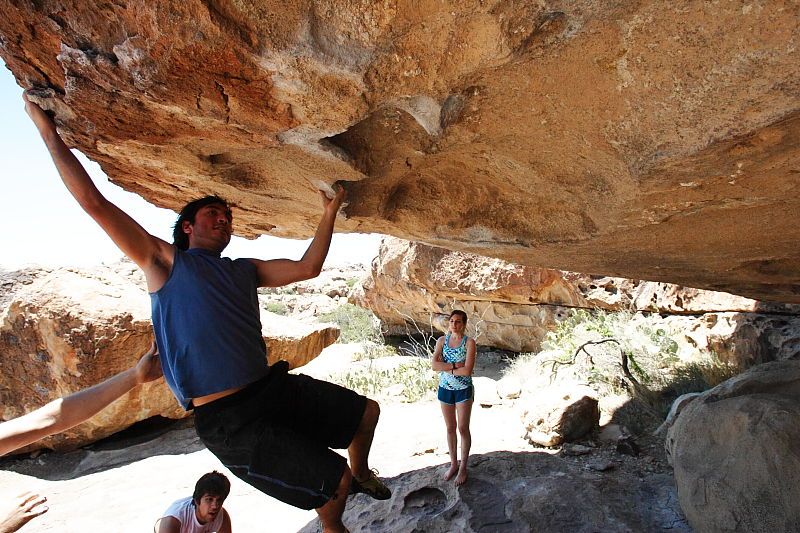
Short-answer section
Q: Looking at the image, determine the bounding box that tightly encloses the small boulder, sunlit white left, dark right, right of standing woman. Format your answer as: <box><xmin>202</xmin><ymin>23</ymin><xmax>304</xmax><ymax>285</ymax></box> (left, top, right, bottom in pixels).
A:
<box><xmin>520</xmin><ymin>384</ymin><xmax>600</xmax><ymax>446</ymax></box>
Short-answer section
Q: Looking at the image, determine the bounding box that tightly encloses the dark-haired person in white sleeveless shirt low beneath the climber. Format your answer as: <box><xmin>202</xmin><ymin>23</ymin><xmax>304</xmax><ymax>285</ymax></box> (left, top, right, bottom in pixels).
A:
<box><xmin>155</xmin><ymin>470</ymin><xmax>231</xmax><ymax>533</ymax></box>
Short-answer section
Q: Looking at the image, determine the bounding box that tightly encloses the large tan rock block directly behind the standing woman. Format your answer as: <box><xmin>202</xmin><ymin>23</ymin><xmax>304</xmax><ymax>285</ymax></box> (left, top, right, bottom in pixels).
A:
<box><xmin>350</xmin><ymin>238</ymin><xmax>580</xmax><ymax>352</ymax></box>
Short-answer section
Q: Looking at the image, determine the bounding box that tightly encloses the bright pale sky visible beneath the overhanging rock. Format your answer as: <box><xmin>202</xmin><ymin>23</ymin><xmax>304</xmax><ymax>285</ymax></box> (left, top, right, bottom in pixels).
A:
<box><xmin>0</xmin><ymin>61</ymin><xmax>380</xmax><ymax>270</ymax></box>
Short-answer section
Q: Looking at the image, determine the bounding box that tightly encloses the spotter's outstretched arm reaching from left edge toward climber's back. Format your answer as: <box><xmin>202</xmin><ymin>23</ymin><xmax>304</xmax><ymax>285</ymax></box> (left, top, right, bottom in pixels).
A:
<box><xmin>0</xmin><ymin>343</ymin><xmax>161</xmax><ymax>455</ymax></box>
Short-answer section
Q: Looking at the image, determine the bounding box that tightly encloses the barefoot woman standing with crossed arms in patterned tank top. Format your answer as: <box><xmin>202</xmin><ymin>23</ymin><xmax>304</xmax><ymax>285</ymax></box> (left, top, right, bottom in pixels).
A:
<box><xmin>431</xmin><ymin>310</ymin><xmax>475</xmax><ymax>486</ymax></box>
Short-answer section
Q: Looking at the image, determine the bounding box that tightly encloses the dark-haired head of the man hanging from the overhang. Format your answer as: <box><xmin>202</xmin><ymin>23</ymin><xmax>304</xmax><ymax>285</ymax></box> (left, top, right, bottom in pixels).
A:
<box><xmin>172</xmin><ymin>196</ymin><xmax>233</xmax><ymax>252</ymax></box>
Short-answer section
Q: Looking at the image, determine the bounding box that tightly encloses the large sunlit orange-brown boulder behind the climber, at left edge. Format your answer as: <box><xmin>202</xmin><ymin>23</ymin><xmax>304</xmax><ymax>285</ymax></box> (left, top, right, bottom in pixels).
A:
<box><xmin>0</xmin><ymin>262</ymin><xmax>338</xmax><ymax>450</ymax></box>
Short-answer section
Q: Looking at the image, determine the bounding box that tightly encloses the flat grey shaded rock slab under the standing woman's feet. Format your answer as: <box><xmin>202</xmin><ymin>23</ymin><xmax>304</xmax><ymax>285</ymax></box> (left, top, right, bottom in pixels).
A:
<box><xmin>300</xmin><ymin>452</ymin><xmax>690</xmax><ymax>533</ymax></box>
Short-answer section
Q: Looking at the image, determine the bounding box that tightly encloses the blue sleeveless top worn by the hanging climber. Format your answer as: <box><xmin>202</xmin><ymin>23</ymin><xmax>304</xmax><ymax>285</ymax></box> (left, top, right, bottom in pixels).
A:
<box><xmin>150</xmin><ymin>248</ymin><xmax>269</xmax><ymax>409</ymax></box>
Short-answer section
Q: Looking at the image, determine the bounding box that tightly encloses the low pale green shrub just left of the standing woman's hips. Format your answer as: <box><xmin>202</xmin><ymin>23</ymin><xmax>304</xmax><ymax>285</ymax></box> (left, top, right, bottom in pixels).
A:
<box><xmin>331</xmin><ymin>357</ymin><xmax>438</xmax><ymax>402</ymax></box>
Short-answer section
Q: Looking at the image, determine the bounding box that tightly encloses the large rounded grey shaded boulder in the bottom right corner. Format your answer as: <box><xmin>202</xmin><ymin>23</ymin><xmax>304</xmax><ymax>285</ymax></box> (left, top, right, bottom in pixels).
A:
<box><xmin>667</xmin><ymin>360</ymin><xmax>800</xmax><ymax>532</ymax></box>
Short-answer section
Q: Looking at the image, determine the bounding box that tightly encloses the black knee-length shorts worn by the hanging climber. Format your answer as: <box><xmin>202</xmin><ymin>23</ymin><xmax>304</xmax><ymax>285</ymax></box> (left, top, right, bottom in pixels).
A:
<box><xmin>194</xmin><ymin>362</ymin><xmax>367</xmax><ymax>509</ymax></box>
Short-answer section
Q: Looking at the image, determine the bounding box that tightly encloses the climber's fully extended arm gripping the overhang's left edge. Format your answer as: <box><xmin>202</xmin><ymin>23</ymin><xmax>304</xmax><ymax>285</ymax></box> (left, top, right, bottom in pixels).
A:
<box><xmin>23</xmin><ymin>95</ymin><xmax>174</xmax><ymax>291</ymax></box>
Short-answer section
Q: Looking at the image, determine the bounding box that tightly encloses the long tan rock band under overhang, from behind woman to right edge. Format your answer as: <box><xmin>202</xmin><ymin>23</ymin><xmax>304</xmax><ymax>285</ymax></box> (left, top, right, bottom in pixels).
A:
<box><xmin>351</xmin><ymin>238</ymin><xmax>800</xmax><ymax>358</ymax></box>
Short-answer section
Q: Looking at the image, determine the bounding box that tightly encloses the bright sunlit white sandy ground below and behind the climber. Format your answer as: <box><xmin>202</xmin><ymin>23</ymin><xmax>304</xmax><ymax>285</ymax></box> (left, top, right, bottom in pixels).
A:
<box><xmin>0</xmin><ymin>345</ymin><xmax>531</xmax><ymax>533</ymax></box>
